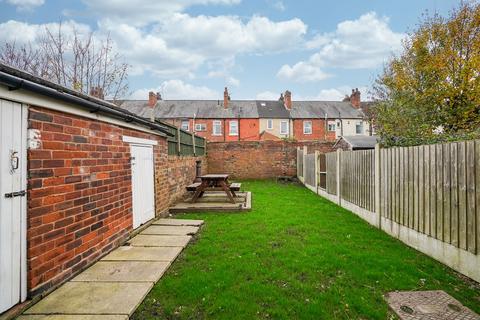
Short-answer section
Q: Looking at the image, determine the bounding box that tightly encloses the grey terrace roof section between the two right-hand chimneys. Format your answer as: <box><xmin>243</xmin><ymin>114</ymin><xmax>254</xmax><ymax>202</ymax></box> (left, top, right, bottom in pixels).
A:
<box><xmin>290</xmin><ymin>101</ymin><xmax>364</xmax><ymax>119</ymax></box>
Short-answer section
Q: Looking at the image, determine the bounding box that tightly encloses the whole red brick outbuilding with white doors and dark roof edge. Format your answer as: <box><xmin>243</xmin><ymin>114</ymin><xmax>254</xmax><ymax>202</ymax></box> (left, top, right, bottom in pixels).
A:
<box><xmin>0</xmin><ymin>64</ymin><xmax>204</xmax><ymax>313</ymax></box>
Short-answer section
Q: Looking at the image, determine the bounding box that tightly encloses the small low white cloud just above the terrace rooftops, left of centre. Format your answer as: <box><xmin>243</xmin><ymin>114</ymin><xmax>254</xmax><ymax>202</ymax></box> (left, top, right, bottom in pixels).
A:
<box><xmin>130</xmin><ymin>80</ymin><xmax>218</xmax><ymax>100</ymax></box>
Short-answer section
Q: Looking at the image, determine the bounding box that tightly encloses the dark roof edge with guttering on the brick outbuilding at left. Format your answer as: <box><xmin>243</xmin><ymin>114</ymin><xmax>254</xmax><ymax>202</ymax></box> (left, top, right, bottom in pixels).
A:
<box><xmin>0</xmin><ymin>63</ymin><xmax>170</xmax><ymax>135</ymax></box>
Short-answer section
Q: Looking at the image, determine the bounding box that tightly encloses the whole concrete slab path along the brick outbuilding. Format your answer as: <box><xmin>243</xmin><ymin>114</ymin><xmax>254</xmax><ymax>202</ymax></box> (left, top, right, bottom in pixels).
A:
<box><xmin>18</xmin><ymin>219</ymin><xmax>203</xmax><ymax>320</ymax></box>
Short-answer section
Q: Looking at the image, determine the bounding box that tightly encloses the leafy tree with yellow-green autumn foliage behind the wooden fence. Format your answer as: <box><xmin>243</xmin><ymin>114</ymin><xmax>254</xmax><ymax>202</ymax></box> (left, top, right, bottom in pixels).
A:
<box><xmin>370</xmin><ymin>2</ymin><xmax>480</xmax><ymax>146</ymax></box>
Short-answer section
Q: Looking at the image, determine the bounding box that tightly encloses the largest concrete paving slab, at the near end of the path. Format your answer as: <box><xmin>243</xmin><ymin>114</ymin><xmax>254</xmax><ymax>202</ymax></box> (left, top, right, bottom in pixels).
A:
<box><xmin>25</xmin><ymin>282</ymin><xmax>153</xmax><ymax>316</ymax></box>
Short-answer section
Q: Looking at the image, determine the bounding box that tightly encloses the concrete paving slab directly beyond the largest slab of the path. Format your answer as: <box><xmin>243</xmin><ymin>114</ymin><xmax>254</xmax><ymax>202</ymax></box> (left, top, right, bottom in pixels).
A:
<box><xmin>71</xmin><ymin>261</ymin><xmax>170</xmax><ymax>283</ymax></box>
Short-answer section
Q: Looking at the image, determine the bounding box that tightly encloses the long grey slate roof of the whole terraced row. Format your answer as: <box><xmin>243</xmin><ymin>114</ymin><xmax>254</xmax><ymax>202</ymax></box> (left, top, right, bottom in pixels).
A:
<box><xmin>121</xmin><ymin>100</ymin><xmax>364</xmax><ymax>119</ymax></box>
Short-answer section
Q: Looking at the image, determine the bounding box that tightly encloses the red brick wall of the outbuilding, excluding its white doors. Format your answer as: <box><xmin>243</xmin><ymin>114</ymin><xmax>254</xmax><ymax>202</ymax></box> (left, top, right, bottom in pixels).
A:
<box><xmin>27</xmin><ymin>107</ymin><xmax>202</xmax><ymax>295</ymax></box>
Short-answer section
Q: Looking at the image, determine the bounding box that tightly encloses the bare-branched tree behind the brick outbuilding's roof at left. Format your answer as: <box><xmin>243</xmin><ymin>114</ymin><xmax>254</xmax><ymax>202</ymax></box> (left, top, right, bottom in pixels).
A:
<box><xmin>0</xmin><ymin>23</ymin><xmax>129</xmax><ymax>101</ymax></box>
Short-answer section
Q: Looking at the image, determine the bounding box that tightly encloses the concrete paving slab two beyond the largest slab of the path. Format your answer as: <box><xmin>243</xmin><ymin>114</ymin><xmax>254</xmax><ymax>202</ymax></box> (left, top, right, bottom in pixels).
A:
<box><xmin>101</xmin><ymin>246</ymin><xmax>182</xmax><ymax>262</ymax></box>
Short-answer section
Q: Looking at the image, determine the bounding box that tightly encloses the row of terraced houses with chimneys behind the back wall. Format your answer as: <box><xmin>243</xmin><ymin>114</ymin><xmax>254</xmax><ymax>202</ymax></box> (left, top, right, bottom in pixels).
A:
<box><xmin>121</xmin><ymin>88</ymin><xmax>372</xmax><ymax>142</ymax></box>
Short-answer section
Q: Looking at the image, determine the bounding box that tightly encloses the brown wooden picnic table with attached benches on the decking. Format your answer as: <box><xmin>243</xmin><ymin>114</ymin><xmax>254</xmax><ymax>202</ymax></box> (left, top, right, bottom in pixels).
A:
<box><xmin>187</xmin><ymin>174</ymin><xmax>242</xmax><ymax>203</ymax></box>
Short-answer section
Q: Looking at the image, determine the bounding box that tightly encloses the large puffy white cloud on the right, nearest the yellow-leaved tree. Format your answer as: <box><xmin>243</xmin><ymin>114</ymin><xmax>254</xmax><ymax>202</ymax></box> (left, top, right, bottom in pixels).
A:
<box><xmin>277</xmin><ymin>12</ymin><xmax>405</xmax><ymax>82</ymax></box>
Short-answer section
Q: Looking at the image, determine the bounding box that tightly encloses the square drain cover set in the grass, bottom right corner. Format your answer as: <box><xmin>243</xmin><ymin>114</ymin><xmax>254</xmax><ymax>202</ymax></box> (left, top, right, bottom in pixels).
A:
<box><xmin>385</xmin><ymin>290</ymin><xmax>480</xmax><ymax>320</ymax></box>
